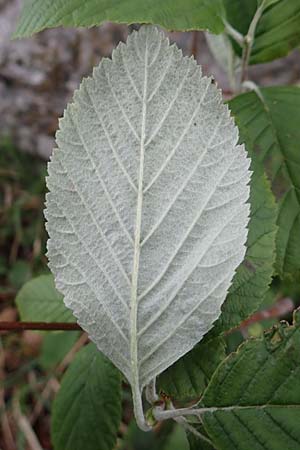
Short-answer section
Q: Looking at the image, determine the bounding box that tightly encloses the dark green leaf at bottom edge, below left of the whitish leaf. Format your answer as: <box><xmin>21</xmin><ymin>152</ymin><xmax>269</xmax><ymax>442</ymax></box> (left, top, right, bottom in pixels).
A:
<box><xmin>51</xmin><ymin>344</ymin><xmax>121</xmax><ymax>450</ymax></box>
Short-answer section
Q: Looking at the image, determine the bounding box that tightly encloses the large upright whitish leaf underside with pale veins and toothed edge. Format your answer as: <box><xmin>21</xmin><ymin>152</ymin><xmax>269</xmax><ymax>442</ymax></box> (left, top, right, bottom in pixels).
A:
<box><xmin>46</xmin><ymin>26</ymin><xmax>250</xmax><ymax>428</ymax></box>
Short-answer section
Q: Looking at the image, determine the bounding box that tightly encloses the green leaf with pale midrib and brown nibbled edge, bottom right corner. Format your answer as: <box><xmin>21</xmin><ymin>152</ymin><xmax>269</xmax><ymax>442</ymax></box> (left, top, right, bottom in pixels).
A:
<box><xmin>202</xmin><ymin>311</ymin><xmax>300</xmax><ymax>450</ymax></box>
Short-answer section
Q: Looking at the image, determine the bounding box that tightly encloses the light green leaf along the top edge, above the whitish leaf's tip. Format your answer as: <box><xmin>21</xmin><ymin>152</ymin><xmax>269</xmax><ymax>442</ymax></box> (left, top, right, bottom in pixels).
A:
<box><xmin>15</xmin><ymin>0</ymin><xmax>224</xmax><ymax>37</ymax></box>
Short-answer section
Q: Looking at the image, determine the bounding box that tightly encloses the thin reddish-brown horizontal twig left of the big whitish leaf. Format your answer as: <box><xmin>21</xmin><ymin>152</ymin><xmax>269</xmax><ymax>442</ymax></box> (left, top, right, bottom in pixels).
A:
<box><xmin>0</xmin><ymin>322</ymin><xmax>82</xmax><ymax>331</ymax></box>
